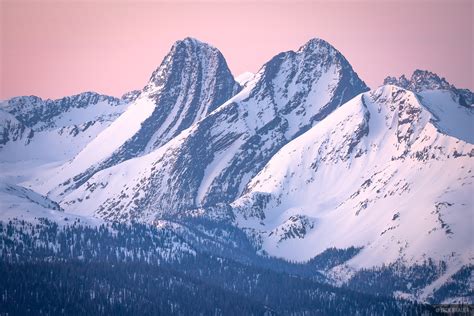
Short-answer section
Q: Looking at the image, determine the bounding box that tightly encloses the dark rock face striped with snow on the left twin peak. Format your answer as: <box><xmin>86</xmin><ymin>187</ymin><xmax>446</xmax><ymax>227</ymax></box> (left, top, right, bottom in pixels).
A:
<box><xmin>105</xmin><ymin>38</ymin><xmax>240</xmax><ymax>160</ymax></box>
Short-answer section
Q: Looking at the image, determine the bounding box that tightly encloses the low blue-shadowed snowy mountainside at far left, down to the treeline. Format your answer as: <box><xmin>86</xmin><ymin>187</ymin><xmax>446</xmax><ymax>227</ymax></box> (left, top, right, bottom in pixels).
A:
<box><xmin>0</xmin><ymin>92</ymin><xmax>133</xmax><ymax>226</ymax></box>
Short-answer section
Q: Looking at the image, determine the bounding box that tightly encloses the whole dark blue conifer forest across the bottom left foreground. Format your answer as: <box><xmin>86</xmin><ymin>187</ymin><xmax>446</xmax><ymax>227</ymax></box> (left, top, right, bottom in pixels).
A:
<box><xmin>0</xmin><ymin>220</ymin><xmax>436</xmax><ymax>315</ymax></box>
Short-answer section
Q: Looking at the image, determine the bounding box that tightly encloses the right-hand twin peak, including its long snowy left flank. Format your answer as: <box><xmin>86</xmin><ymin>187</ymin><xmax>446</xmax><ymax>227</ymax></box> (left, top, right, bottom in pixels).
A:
<box><xmin>61</xmin><ymin>39</ymin><xmax>367</xmax><ymax>220</ymax></box>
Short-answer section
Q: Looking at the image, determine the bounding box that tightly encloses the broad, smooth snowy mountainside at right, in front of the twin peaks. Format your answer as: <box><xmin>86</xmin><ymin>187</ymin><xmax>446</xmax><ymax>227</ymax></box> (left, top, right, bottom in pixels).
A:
<box><xmin>232</xmin><ymin>85</ymin><xmax>474</xmax><ymax>269</ymax></box>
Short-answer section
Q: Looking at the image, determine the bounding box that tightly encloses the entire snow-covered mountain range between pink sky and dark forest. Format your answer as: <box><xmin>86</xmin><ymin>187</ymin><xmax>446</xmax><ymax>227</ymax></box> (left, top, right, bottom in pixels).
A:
<box><xmin>0</xmin><ymin>38</ymin><xmax>474</xmax><ymax>301</ymax></box>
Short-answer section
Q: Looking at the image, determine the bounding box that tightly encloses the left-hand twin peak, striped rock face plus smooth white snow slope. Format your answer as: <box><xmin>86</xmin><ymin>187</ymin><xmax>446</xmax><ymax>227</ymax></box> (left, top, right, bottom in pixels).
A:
<box><xmin>41</xmin><ymin>38</ymin><xmax>240</xmax><ymax>195</ymax></box>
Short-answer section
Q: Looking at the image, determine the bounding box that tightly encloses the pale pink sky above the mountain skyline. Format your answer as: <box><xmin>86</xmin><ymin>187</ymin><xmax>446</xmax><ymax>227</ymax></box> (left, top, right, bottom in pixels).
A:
<box><xmin>0</xmin><ymin>0</ymin><xmax>474</xmax><ymax>99</ymax></box>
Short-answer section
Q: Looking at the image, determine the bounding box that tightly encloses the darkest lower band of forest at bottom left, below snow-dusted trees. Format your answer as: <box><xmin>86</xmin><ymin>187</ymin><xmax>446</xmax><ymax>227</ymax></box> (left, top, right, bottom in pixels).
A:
<box><xmin>0</xmin><ymin>260</ymin><xmax>265</xmax><ymax>315</ymax></box>
